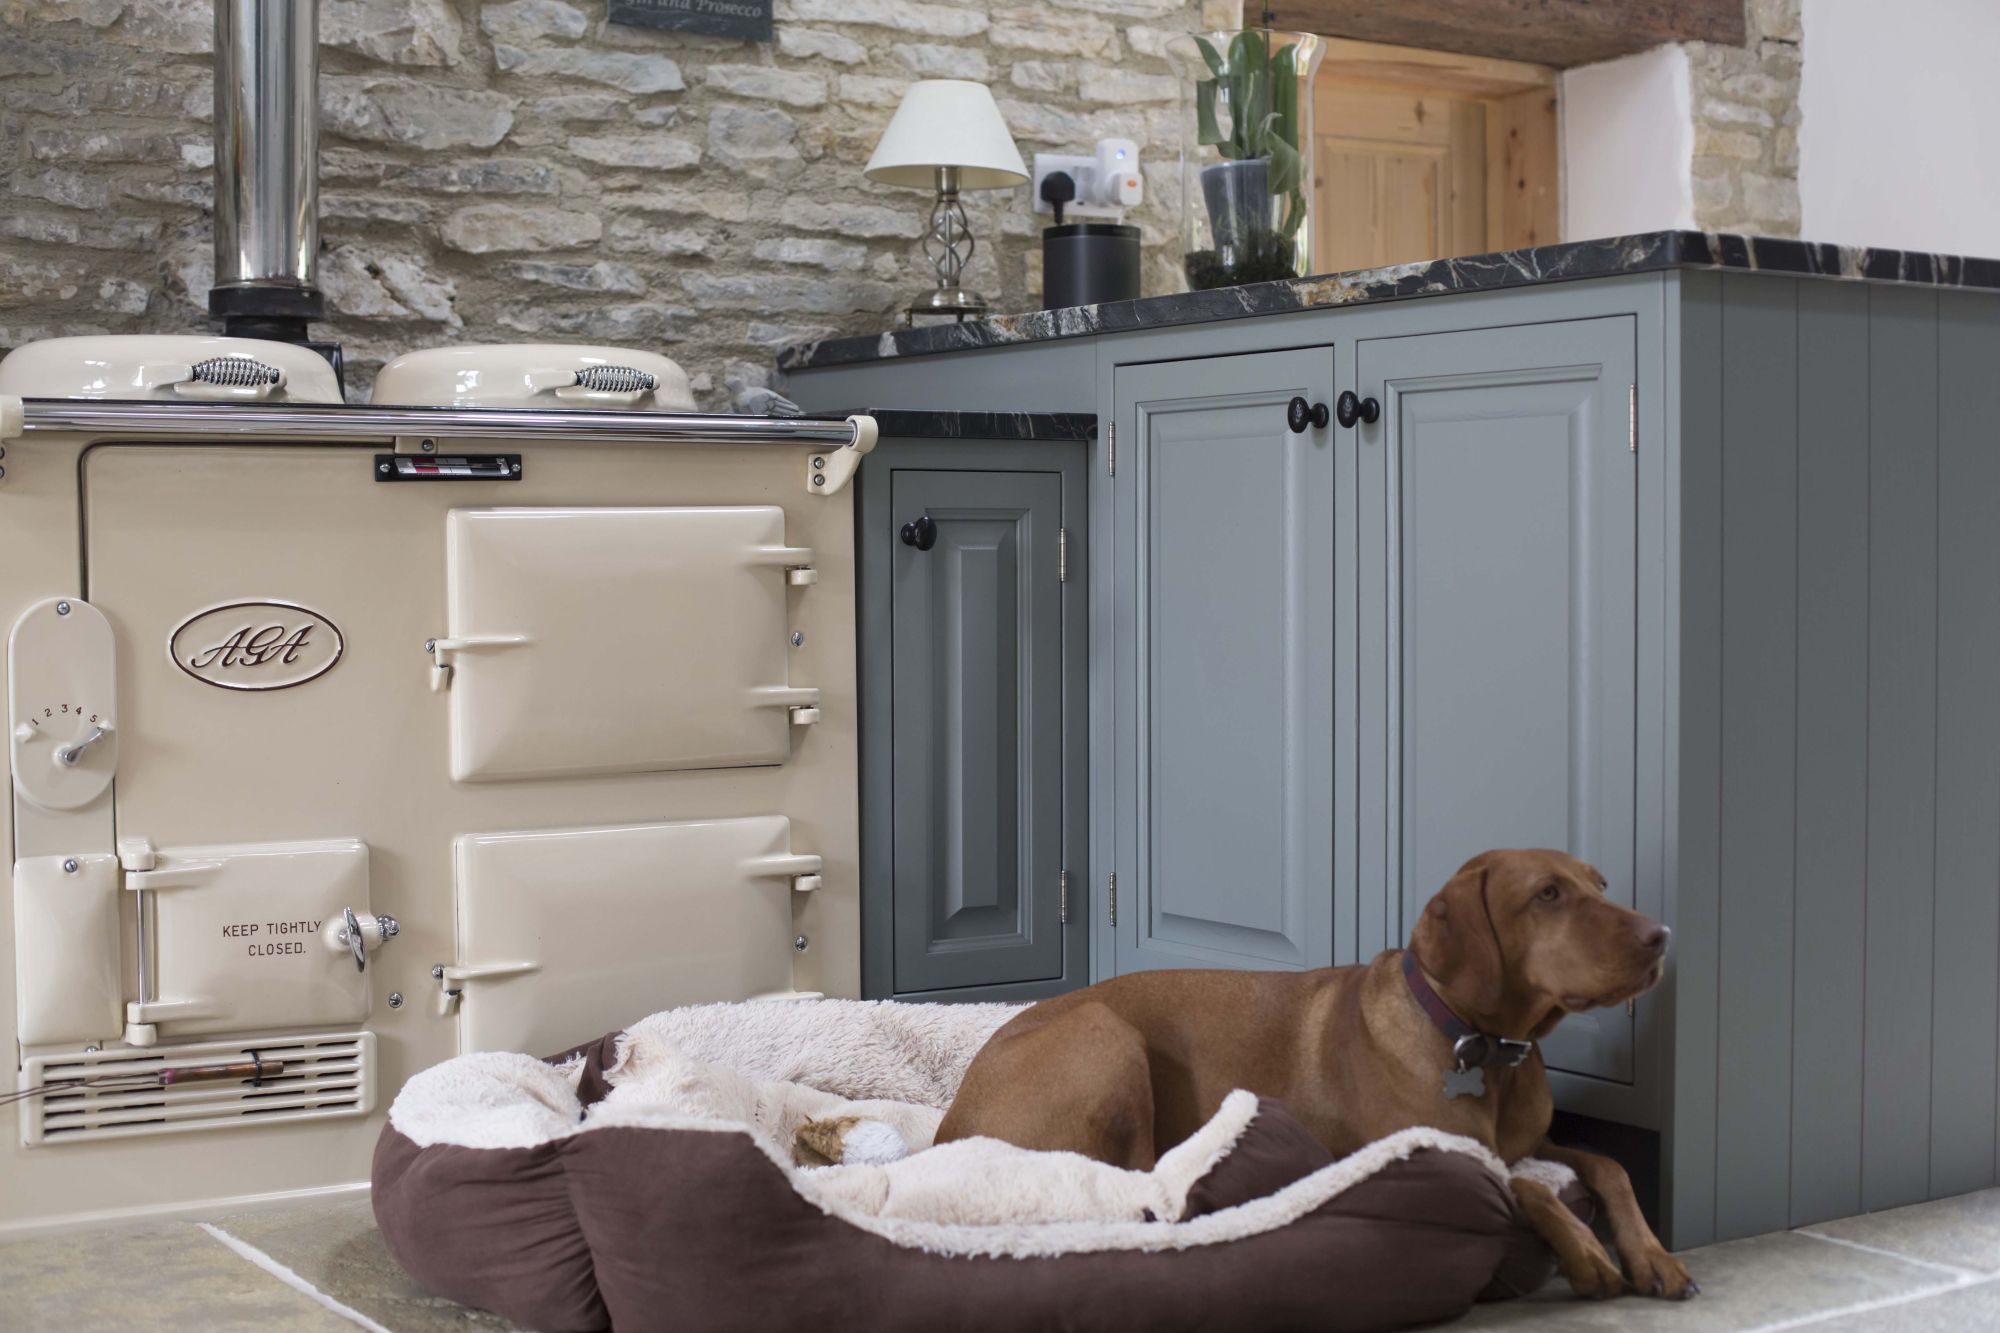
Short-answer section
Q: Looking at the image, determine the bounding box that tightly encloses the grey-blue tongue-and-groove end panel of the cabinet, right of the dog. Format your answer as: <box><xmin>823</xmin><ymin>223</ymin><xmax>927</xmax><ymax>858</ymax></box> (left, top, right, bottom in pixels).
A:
<box><xmin>1672</xmin><ymin>274</ymin><xmax>2000</xmax><ymax>1243</ymax></box>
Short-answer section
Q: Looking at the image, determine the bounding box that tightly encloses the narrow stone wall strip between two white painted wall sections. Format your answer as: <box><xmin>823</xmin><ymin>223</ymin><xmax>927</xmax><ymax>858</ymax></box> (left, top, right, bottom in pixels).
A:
<box><xmin>1688</xmin><ymin>0</ymin><xmax>1804</xmax><ymax>236</ymax></box>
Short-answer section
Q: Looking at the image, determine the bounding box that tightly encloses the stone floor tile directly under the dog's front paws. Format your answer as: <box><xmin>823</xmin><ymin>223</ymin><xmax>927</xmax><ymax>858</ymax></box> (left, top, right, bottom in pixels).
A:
<box><xmin>1448</xmin><ymin>1231</ymin><xmax>1952</xmax><ymax>1333</ymax></box>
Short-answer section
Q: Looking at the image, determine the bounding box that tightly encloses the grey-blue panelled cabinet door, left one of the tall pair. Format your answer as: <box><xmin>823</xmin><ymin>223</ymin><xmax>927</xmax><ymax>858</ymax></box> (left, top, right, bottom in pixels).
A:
<box><xmin>1098</xmin><ymin>348</ymin><xmax>1338</xmax><ymax>973</ymax></box>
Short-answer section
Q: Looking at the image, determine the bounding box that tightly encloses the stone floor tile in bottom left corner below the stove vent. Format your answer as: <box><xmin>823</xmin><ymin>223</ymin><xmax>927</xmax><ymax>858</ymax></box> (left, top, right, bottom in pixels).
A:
<box><xmin>0</xmin><ymin>1221</ymin><xmax>354</xmax><ymax>1333</ymax></box>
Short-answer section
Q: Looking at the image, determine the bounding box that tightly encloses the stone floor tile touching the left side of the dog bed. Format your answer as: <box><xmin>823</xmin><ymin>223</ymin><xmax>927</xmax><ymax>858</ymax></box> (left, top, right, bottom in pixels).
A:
<box><xmin>206</xmin><ymin>1197</ymin><xmax>516</xmax><ymax>1333</ymax></box>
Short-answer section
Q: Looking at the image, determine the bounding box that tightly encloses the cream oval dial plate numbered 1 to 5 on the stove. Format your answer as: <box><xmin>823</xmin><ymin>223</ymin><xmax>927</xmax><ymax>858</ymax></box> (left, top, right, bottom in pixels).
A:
<box><xmin>8</xmin><ymin>596</ymin><xmax>118</xmax><ymax>811</ymax></box>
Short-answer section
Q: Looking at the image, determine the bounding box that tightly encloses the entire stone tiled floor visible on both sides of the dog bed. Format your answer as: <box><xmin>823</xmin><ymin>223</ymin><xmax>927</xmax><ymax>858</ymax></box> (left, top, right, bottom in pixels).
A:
<box><xmin>11</xmin><ymin>1191</ymin><xmax>2000</xmax><ymax>1333</ymax></box>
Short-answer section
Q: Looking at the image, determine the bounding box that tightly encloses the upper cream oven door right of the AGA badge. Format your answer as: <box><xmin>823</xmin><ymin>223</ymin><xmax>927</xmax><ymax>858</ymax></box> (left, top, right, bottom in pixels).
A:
<box><xmin>432</xmin><ymin>504</ymin><xmax>820</xmax><ymax>781</ymax></box>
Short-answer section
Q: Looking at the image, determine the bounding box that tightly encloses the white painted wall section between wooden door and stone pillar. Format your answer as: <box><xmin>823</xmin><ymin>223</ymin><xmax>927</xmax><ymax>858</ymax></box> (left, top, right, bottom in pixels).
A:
<box><xmin>1562</xmin><ymin>46</ymin><xmax>1694</xmax><ymax>240</ymax></box>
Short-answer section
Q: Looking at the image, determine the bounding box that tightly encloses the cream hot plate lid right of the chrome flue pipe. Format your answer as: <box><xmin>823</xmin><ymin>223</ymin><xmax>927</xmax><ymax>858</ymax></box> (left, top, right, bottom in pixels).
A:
<box><xmin>374</xmin><ymin>342</ymin><xmax>694</xmax><ymax>412</ymax></box>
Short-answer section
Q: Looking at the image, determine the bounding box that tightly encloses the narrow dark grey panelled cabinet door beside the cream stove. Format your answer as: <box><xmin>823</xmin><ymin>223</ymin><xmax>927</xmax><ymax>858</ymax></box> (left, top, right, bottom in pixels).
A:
<box><xmin>890</xmin><ymin>470</ymin><xmax>1062</xmax><ymax>993</ymax></box>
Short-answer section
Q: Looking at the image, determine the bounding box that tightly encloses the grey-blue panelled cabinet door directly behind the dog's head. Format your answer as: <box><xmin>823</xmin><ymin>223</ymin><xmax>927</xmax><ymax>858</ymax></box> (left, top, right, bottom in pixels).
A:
<box><xmin>1356</xmin><ymin>316</ymin><xmax>1638</xmax><ymax>1083</ymax></box>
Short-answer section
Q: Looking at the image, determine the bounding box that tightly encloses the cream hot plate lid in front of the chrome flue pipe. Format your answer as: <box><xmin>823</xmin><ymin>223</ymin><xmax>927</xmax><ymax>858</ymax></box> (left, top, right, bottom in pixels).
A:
<box><xmin>0</xmin><ymin>334</ymin><xmax>340</xmax><ymax>402</ymax></box>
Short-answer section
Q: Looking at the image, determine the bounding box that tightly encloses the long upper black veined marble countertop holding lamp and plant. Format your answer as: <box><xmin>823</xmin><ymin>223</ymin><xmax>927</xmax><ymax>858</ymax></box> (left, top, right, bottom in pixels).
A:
<box><xmin>778</xmin><ymin>232</ymin><xmax>2000</xmax><ymax>370</ymax></box>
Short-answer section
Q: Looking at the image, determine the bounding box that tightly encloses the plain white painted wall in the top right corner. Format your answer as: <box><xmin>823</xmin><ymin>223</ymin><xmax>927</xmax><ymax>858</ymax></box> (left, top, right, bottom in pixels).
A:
<box><xmin>1798</xmin><ymin>0</ymin><xmax>2000</xmax><ymax>256</ymax></box>
